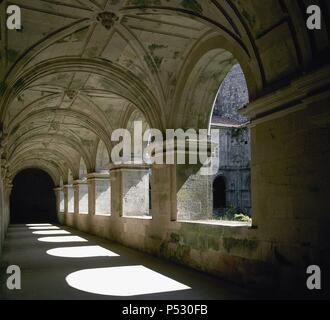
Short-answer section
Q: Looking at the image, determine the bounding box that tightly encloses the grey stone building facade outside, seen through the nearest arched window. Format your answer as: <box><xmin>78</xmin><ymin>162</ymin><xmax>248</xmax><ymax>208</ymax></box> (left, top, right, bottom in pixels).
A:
<box><xmin>211</xmin><ymin>65</ymin><xmax>251</xmax><ymax>215</ymax></box>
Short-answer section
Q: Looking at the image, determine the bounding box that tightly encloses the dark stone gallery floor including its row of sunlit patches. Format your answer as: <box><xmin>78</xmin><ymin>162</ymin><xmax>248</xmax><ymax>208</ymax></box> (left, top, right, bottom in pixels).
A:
<box><xmin>0</xmin><ymin>225</ymin><xmax>254</xmax><ymax>300</ymax></box>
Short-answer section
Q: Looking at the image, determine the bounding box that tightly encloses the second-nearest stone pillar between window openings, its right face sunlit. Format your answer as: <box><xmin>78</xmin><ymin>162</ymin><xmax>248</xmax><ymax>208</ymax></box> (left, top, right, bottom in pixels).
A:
<box><xmin>110</xmin><ymin>164</ymin><xmax>150</xmax><ymax>217</ymax></box>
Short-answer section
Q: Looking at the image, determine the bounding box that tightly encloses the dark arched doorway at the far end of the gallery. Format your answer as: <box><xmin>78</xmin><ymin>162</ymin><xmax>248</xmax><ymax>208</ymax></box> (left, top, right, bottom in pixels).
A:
<box><xmin>10</xmin><ymin>169</ymin><xmax>57</xmax><ymax>224</ymax></box>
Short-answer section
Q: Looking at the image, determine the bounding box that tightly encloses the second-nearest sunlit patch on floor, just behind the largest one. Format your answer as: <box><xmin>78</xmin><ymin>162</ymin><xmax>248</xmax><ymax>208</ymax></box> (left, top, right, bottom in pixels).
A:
<box><xmin>47</xmin><ymin>246</ymin><xmax>119</xmax><ymax>258</ymax></box>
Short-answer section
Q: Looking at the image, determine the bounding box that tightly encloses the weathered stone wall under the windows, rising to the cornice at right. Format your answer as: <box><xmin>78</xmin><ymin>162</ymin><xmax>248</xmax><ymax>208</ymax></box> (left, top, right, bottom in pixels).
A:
<box><xmin>61</xmin><ymin>95</ymin><xmax>330</xmax><ymax>292</ymax></box>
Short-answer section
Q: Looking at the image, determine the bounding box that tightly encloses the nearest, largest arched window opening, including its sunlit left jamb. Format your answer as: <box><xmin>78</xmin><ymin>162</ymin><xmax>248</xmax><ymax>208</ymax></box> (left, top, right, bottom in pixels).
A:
<box><xmin>177</xmin><ymin>59</ymin><xmax>251</xmax><ymax>225</ymax></box>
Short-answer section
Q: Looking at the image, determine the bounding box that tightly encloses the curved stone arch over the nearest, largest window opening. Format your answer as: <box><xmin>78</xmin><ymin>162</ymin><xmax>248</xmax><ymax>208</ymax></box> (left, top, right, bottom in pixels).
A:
<box><xmin>171</xmin><ymin>36</ymin><xmax>262</xmax><ymax>128</ymax></box>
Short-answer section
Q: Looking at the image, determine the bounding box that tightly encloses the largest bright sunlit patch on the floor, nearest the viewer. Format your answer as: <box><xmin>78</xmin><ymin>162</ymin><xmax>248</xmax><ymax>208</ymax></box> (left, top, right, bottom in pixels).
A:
<box><xmin>66</xmin><ymin>266</ymin><xmax>191</xmax><ymax>297</ymax></box>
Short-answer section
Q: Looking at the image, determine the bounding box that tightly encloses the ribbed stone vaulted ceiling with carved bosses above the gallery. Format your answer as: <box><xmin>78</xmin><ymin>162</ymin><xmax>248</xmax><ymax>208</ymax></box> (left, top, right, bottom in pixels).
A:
<box><xmin>0</xmin><ymin>0</ymin><xmax>329</xmax><ymax>181</ymax></box>
